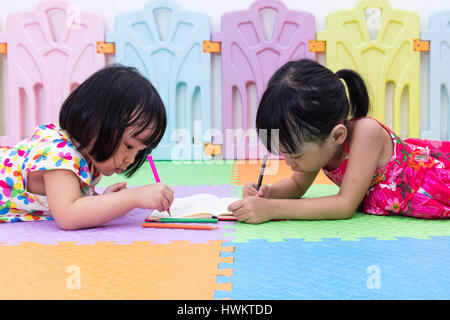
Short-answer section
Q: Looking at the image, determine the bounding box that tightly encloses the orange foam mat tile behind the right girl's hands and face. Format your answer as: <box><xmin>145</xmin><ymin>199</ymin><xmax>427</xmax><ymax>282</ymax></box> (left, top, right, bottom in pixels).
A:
<box><xmin>231</xmin><ymin>160</ymin><xmax>334</xmax><ymax>186</ymax></box>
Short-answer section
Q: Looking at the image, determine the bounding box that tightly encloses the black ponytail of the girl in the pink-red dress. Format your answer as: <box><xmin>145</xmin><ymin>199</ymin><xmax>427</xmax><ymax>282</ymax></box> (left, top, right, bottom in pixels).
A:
<box><xmin>336</xmin><ymin>69</ymin><xmax>369</xmax><ymax>119</ymax></box>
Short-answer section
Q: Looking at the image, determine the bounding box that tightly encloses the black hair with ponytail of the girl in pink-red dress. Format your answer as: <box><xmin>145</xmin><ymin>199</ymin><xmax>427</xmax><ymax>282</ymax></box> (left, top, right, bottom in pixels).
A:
<box><xmin>256</xmin><ymin>59</ymin><xmax>369</xmax><ymax>154</ymax></box>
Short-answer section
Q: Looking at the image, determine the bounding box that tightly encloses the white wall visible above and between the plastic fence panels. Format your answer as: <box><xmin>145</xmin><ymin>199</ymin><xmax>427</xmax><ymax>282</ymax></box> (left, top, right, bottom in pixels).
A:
<box><xmin>0</xmin><ymin>0</ymin><xmax>450</xmax><ymax>135</ymax></box>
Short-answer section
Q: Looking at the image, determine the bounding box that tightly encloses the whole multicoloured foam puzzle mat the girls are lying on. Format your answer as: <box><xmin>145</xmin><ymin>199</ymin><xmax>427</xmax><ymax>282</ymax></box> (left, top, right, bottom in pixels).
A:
<box><xmin>0</xmin><ymin>160</ymin><xmax>450</xmax><ymax>300</ymax></box>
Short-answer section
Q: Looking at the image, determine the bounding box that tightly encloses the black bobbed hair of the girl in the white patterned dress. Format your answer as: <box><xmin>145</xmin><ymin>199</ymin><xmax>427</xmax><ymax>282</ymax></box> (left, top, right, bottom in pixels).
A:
<box><xmin>59</xmin><ymin>64</ymin><xmax>167</xmax><ymax>177</ymax></box>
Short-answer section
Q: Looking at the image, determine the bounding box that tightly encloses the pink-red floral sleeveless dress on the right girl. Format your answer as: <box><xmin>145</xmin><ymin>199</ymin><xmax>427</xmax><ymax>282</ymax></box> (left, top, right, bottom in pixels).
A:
<box><xmin>322</xmin><ymin>119</ymin><xmax>450</xmax><ymax>219</ymax></box>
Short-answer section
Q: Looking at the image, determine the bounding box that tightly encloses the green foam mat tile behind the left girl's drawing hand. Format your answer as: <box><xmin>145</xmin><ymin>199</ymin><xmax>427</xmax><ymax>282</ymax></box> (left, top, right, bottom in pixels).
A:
<box><xmin>98</xmin><ymin>160</ymin><xmax>234</xmax><ymax>187</ymax></box>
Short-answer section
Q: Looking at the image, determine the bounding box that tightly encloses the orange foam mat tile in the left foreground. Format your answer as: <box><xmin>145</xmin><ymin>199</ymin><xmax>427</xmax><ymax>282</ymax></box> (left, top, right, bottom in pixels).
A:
<box><xmin>0</xmin><ymin>241</ymin><xmax>231</xmax><ymax>300</ymax></box>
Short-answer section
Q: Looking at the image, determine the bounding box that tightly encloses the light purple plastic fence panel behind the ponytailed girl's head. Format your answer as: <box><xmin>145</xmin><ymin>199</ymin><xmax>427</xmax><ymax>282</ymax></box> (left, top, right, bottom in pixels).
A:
<box><xmin>212</xmin><ymin>0</ymin><xmax>315</xmax><ymax>159</ymax></box>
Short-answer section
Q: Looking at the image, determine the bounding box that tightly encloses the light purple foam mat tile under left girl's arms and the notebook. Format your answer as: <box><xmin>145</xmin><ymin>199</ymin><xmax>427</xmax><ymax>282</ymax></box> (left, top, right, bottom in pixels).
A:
<box><xmin>0</xmin><ymin>186</ymin><xmax>234</xmax><ymax>245</ymax></box>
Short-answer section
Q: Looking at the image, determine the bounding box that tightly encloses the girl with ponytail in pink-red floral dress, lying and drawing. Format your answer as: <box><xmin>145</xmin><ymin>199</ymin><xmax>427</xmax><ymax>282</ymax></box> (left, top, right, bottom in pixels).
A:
<box><xmin>229</xmin><ymin>59</ymin><xmax>450</xmax><ymax>223</ymax></box>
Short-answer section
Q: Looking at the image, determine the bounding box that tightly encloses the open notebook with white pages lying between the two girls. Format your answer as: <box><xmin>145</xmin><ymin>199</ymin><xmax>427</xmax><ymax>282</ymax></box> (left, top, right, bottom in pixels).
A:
<box><xmin>147</xmin><ymin>193</ymin><xmax>239</xmax><ymax>219</ymax></box>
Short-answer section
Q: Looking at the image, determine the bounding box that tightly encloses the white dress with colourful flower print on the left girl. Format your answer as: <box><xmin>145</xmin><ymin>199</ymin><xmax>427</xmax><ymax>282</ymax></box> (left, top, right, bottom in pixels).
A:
<box><xmin>0</xmin><ymin>123</ymin><xmax>101</xmax><ymax>222</ymax></box>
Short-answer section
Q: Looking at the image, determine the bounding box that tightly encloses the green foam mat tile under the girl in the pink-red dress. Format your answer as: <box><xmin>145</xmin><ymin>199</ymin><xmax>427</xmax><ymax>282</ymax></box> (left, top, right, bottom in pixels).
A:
<box><xmin>226</xmin><ymin>185</ymin><xmax>450</xmax><ymax>242</ymax></box>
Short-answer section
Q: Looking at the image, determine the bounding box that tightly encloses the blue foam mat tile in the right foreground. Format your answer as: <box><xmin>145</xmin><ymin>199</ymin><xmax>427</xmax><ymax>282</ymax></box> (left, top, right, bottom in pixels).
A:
<box><xmin>221</xmin><ymin>236</ymin><xmax>450</xmax><ymax>300</ymax></box>
